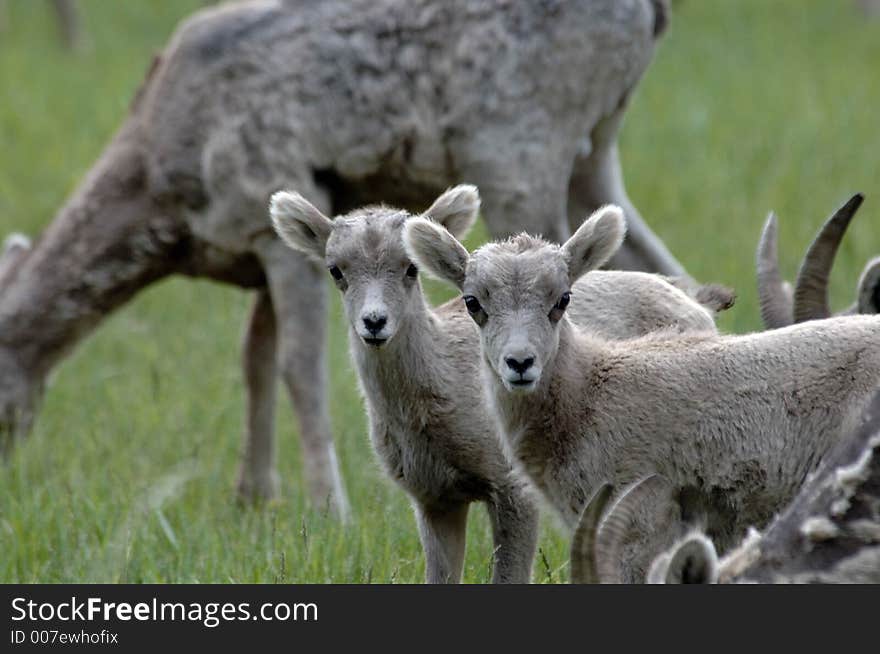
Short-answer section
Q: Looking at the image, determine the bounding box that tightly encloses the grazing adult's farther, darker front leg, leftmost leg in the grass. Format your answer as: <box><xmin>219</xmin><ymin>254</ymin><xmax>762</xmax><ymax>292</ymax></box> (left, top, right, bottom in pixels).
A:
<box><xmin>238</xmin><ymin>291</ymin><xmax>278</xmax><ymax>501</ymax></box>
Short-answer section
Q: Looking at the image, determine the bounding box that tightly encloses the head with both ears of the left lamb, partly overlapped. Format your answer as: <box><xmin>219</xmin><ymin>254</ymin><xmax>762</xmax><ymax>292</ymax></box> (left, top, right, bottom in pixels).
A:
<box><xmin>270</xmin><ymin>186</ymin><xmax>480</xmax><ymax>347</ymax></box>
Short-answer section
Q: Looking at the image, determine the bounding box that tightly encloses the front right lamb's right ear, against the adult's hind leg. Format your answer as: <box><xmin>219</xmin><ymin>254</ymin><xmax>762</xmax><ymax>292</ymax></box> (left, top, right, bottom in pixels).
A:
<box><xmin>562</xmin><ymin>204</ymin><xmax>626</xmax><ymax>284</ymax></box>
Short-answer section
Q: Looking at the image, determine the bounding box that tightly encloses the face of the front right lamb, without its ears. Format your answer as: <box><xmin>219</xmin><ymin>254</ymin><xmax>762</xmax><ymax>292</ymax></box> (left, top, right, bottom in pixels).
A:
<box><xmin>463</xmin><ymin>235</ymin><xmax>571</xmax><ymax>392</ymax></box>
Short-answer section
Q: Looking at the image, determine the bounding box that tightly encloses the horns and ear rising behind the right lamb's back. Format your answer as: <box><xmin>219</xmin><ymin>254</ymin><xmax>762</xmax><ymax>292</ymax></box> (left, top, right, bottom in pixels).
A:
<box><xmin>757</xmin><ymin>193</ymin><xmax>880</xmax><ymax>329</ymax></box>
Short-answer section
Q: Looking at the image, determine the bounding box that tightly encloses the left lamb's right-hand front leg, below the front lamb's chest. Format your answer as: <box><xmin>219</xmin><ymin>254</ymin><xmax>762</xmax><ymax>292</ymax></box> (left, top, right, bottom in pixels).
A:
<box><xmin>488</xmin><ymin>484</ymin><xmax>538</xmax><ymax>584</ymax></box>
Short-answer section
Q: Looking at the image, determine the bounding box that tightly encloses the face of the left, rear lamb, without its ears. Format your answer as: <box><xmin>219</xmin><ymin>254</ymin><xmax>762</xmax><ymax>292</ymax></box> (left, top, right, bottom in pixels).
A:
<box><xmin>325</xmin><ymin>213</ymin><xmax>420</xmax><ymax>347</ymax></box>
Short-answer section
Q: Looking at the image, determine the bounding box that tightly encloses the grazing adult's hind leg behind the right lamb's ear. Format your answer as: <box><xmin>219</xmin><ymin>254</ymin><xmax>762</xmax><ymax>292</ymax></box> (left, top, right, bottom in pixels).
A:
<box><xmin>568</xmin><ymin>108</ymin><xmax>687</xmax><ymax>278</ymax></box>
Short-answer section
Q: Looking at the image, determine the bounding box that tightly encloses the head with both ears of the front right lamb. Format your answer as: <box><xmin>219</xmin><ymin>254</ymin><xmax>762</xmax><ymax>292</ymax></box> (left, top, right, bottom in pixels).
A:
<box><xmin>404</xmin><ymin>206</ymin><xmax>625</xmax><ymax>392</ymax></box>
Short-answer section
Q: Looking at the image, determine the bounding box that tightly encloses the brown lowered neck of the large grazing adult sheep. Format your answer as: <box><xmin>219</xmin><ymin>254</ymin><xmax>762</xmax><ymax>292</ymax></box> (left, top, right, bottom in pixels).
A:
<box><xmin>0</xmin><ymin>127</ymin><xmax>184</xmax><ymax>375</ymax></box>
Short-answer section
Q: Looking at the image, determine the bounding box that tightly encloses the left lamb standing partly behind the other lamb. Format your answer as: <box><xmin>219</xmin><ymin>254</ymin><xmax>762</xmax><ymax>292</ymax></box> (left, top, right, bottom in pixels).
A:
<box><xmin>270</xmin><ymin>186</ymin><xmax>728</xmax><ymax>583</ymax></box>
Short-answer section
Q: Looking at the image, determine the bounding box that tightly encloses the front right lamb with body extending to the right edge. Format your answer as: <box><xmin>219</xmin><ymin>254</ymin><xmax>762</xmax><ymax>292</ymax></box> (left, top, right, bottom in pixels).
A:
<box><xmin>404</xmin><ymin>207</ymin><xmax>880</xmax><ymax>572</ymax></box>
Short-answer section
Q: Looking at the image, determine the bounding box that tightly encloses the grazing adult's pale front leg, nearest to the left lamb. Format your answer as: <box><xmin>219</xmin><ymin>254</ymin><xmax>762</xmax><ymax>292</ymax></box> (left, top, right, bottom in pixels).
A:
<box><xmin>259</xmin><ymin>237</ymin><xmax>349</xmax><ymax>521</ymax></box>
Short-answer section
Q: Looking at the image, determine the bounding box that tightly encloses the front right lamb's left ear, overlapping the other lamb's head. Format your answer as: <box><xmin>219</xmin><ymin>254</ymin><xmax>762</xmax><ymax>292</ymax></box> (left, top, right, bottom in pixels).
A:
<box><xmin>403</xmin><ymin>217</ymin><xmax>470</xmax><ymax>290</ymax></box>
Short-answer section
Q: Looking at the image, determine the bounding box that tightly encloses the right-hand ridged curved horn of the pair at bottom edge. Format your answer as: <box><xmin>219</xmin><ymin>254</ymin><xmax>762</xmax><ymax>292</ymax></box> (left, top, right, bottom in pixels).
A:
<box><xmin>596</xmin><ymin>475</ymin><xmax>671</xmax><ymax>584</ymax></box>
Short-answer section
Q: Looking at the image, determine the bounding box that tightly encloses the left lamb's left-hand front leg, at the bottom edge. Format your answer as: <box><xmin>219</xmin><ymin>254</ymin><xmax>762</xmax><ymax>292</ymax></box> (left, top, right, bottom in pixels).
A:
<box><xmin>416</xmin><ymin>504</ymin><xmax>469</xmax><ymax>584</ymax></box>
